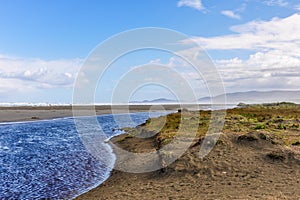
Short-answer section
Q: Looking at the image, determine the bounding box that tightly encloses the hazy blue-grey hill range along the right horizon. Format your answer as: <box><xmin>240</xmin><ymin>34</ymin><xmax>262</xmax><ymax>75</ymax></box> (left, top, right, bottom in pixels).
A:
<box><xmin>199</xmin><ymin>90</ymin><xmax>300</xmax><ymax>104</ymax></box>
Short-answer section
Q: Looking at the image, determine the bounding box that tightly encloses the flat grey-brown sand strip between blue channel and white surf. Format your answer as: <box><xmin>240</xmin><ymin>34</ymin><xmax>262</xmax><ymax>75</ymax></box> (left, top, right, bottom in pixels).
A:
<box><xmin>0</xmin><ymin>105</ymin><xmax>180</xmax><ymax>122</ymax></box>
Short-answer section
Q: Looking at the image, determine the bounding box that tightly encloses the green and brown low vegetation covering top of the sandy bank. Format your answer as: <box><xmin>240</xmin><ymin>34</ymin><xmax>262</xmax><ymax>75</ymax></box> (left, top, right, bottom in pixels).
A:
<box><xmin>119</xmin><ymin>102</ymin><xmax>300</xmax><ymax>146</ymax></box>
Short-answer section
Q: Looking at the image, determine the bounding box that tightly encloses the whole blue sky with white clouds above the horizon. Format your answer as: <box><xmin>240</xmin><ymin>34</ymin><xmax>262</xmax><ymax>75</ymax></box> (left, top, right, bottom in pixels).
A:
<box><xmin>0</xmin><ymin>0</ymin><xmax>300</xmax><ymax>103</ymax></box>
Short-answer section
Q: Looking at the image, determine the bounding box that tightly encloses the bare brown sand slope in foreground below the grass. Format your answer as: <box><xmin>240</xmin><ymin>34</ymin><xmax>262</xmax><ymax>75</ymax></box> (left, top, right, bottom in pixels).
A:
<box><xmin>78</xmin><ymin>132</ymin><xmax>300</xmax><ymax>199</ymax></box>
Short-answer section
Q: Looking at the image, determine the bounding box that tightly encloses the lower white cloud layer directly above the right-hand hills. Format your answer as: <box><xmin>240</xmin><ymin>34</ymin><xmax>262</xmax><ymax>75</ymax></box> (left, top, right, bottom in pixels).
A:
<box><xmin>216</xmin><ymin>50</ymin><xmax>300</xmax><ymax>91</ymax></box>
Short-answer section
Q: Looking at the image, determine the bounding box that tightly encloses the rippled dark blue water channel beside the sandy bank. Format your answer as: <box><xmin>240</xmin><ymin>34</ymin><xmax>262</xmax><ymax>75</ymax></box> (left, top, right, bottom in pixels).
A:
<box><xmin>0</xmin><ymin>112</ymin><xmax>167</xmax><ymax>199</ymax></box>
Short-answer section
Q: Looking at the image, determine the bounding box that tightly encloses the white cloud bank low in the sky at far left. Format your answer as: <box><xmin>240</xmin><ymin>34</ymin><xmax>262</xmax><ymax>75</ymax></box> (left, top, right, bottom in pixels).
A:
<box><xmin>0</xmin><ymin>55</ymin><xmax>82</xmax><ymax>93</ymax></box>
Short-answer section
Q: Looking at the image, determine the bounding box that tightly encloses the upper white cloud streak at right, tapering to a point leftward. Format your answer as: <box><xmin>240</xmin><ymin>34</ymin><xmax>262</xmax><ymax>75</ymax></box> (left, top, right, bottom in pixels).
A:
<box><xmin>186</xmin><ymin>14</ymin><xmax>300</xmax><ymax>56</ymax></box>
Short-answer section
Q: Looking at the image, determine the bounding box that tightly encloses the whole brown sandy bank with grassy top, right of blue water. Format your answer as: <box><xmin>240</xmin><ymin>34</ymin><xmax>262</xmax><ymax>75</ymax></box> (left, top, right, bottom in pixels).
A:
<box><xmin>77</xmin><ymin>103</ymin><xmax>300</xmax><ymax>200</ymax></box>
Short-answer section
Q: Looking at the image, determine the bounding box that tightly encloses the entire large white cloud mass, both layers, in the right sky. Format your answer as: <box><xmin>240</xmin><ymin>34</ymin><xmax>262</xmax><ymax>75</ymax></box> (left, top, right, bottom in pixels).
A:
<box><xmin>178</xmin><ymin>14</ymin><xmax>300</xmax><ymax>92</ymax></box>
